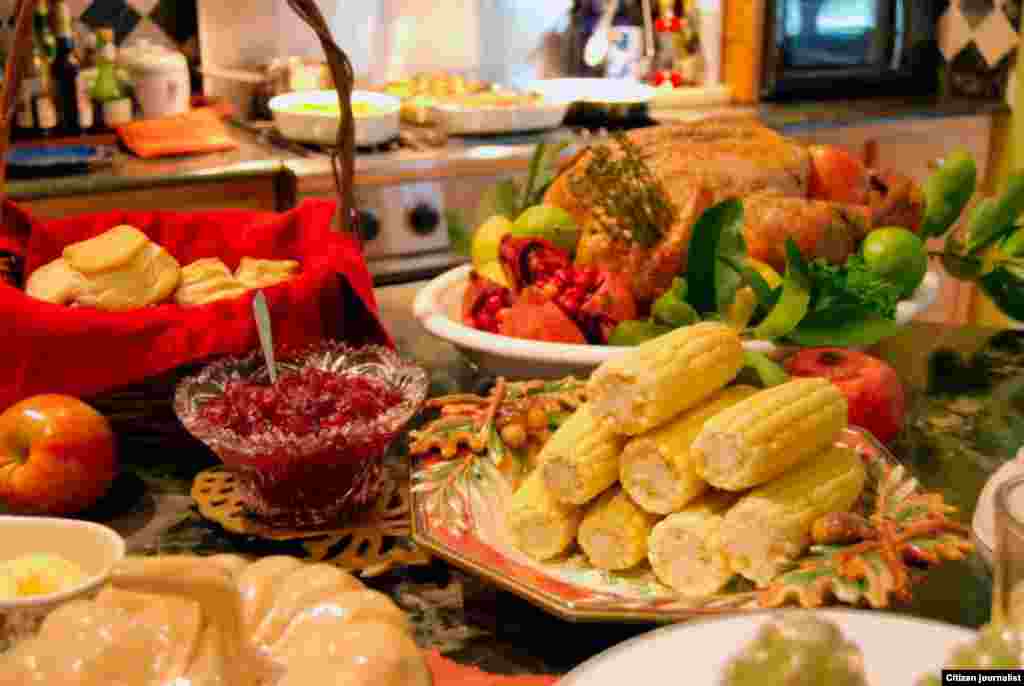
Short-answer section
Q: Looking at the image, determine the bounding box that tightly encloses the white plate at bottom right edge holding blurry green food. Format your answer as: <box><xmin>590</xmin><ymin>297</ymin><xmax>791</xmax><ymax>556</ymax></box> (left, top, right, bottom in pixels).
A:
<box><xmin>558</xmin><ymin>610</ymin><xmax>975</xmax><ymax>686</ymax></box>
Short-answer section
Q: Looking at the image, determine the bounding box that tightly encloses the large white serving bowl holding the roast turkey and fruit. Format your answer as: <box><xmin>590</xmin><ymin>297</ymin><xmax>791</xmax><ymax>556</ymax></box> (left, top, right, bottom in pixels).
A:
<box><xmin>413</xmin><ymin>264</ymin><xmax>939</xmax><ymax>379</ymax></box>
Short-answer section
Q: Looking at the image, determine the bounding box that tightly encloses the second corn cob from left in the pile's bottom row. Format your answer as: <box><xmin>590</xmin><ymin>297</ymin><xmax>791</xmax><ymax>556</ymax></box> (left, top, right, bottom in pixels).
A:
<box><xmin>579</xmin><ymin>486</ymin><xmax>658</xmax><ymax>570</ymax></box>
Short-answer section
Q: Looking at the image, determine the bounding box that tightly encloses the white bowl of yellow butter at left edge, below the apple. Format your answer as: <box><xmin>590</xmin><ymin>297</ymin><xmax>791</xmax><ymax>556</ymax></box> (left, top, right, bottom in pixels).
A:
<box><xmin>0</xmin><ymin>515</ymin><xmax>125</xmax><ymax>613</ymax></box>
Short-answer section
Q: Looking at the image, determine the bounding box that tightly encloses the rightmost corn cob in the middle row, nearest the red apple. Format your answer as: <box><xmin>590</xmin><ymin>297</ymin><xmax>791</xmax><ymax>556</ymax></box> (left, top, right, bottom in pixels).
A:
<box><xmin>691</xmin><ymin>379</ymin><xmax>847</xmax><ymax>490</ymax></box>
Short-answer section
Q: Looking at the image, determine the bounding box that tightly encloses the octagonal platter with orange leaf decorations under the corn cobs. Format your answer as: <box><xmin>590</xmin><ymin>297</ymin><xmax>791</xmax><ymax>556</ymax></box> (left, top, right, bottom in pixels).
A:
<box><xmin>411</xmin><ymin>380</ymin><xmax>971</xmax><ymax>623</ymax></box>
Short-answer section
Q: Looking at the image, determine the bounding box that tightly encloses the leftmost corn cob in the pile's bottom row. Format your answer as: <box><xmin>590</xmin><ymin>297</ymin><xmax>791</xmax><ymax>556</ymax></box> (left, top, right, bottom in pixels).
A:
<box><xmin>506</xmin><ymin>469</ymin><xmax>583</xmax><ymax>560</ymax></box>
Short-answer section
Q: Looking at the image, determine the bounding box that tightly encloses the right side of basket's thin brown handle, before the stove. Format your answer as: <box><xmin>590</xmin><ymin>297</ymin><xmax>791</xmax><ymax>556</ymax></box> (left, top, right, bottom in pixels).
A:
<box><xmin>288</xmin><ymin>0</ymin><xmax>361</xmax><ymax>245</ymax></box>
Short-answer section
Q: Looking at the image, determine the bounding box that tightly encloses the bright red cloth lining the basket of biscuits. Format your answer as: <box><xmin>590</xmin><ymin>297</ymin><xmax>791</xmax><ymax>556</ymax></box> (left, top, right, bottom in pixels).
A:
<box><xmin>0</xmin><ymin>201</ymin><xmax>391</xmax><ymax>410</ymax></box>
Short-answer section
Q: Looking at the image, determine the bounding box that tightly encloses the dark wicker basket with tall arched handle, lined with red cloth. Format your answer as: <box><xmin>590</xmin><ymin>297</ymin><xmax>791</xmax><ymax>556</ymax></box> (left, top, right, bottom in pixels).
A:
<box><xmin>0</xmin><ymin>0</ymin><xmax>357</xmax><ymax>446</ymax></box>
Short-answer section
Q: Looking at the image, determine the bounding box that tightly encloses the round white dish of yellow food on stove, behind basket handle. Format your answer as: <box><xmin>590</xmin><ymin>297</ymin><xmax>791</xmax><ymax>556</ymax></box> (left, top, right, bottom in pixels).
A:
<box><xmin>269</xmin><ymin>90</ymin><xmax>401</xmax><ymax>145</ymax></box>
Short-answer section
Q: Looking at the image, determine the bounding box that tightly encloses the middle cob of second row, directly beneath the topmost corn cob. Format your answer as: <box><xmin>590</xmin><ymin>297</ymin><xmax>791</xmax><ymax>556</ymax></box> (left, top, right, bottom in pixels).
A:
<box><xmin>618</xmin><ymin>386</ymin><xmax>758</xmax><ymax>514</ymax></box>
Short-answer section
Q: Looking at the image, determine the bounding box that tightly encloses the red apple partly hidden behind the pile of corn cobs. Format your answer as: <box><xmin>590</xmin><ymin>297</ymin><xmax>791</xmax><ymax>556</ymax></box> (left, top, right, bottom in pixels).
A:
<box><xmin>785</xmin><ymin>348</ymin><xmax>906</xmax><ymax>443</ymax></box>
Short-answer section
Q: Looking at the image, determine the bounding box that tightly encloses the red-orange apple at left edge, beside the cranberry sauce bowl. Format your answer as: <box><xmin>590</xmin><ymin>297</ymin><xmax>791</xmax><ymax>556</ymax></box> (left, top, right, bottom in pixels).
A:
<box><xmin>0</xmin><ymin>394</ymin><xmax>118</xmax><ymax>515</ymax></box>
